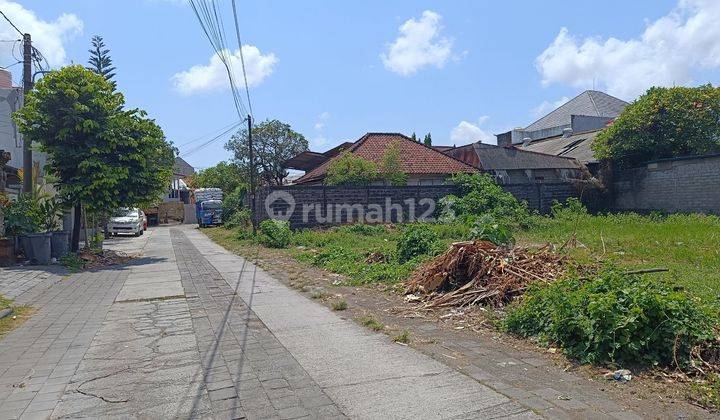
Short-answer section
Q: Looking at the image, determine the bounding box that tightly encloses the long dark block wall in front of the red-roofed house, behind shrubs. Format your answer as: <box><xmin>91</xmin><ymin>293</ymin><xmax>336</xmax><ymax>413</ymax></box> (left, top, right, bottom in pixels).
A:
<box><xmin>256</xmin><ymin>182</ymin><xmax>578</xmax><ymax>228</ymax></box>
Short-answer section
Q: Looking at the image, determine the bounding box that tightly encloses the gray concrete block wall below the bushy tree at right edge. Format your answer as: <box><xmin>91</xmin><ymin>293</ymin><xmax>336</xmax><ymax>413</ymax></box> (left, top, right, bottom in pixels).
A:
<box><xmin>611</xmin><ymin>155</ymin><xmax>720</xmax><ymax>214</ymax></box>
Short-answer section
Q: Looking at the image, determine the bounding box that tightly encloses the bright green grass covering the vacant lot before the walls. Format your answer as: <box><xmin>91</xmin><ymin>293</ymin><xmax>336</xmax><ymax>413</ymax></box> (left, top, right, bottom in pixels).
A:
<box><xmin>205</xmin><ymin>214</ymin><xmax>720</xmax><ymax>300</ymax></box>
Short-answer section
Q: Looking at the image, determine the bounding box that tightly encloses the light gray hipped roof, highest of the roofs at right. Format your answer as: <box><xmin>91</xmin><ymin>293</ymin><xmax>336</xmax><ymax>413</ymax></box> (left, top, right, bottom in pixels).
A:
<box><xmin>525</xmin><ymin>90</ymin><xmax>628</xmax><ymax>131</ymax></box>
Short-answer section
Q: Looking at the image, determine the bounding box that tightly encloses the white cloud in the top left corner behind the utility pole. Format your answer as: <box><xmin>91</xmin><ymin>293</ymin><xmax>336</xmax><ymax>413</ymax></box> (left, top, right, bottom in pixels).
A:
<box><xmin>0</xmin><ymin>0</ymin><xmax>83</xmax><ymax>76</ymax></box>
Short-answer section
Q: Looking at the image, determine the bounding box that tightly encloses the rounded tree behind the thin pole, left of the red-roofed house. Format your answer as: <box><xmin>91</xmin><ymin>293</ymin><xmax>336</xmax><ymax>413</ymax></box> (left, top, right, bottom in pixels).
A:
<box><xmin>225</xmin><ymin>120</ymin><xmax>308</xmax><ymax>185</ymax></box>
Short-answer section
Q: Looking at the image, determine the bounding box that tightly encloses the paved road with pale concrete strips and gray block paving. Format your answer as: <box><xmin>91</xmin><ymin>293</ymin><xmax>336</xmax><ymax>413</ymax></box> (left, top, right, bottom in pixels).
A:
<box><xmin>0</xmin><ymin>226</ymin><xmax>536</xmax><ymax>419</ymax></box>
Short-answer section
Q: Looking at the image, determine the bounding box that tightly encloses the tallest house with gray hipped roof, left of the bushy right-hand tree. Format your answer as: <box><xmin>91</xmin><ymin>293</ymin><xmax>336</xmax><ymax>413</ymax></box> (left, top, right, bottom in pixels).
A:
<box><xmin>496</xmin><ymin>90</ymin><xmax>628</xmax><ymax>173</ymax></box>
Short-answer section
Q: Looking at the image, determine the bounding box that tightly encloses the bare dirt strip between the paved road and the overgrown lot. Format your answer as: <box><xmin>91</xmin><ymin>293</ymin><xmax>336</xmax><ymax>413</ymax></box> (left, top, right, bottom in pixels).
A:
<box><xmin>205</xmin><ymin>238</ymin><xmax>713</xmax><ymax>418</ymax></box>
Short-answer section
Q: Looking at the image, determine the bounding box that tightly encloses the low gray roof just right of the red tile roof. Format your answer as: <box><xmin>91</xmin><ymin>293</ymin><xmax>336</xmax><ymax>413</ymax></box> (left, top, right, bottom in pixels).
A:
<box><xmin>445</xmin><ymin>142</ymin><xmax>580</xmax><ymax>171</ymax></box>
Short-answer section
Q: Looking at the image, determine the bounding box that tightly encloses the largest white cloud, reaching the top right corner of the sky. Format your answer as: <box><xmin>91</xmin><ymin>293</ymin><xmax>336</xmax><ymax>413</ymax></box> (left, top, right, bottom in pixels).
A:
<box><xmin>535</xmin><ymin>0</ymin><xmax>720</xmax><ymax>99</ymax></box>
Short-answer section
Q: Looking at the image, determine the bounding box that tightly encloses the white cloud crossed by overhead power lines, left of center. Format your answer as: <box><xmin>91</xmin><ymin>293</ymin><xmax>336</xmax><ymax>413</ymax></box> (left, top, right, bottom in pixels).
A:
<box><xmin>172</xmin><ymin>45</ymin><xmax>278</xmax><ymax>95</ymax></box>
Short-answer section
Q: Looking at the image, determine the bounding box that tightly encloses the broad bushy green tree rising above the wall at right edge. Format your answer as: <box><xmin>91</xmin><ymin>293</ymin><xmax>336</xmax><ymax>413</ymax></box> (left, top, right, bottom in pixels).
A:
<box><xmin>592</xmin><ymin>85</ymin><xmax>720</xmax><ymax>166</ymax></box>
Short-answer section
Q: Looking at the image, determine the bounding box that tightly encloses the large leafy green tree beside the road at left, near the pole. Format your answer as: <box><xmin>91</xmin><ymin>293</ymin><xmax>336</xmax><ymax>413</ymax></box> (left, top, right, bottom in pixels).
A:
<box><xmin>13</xmin><ymin>65</ymin><xmax>174</xmax><ymax>249</ymax></box>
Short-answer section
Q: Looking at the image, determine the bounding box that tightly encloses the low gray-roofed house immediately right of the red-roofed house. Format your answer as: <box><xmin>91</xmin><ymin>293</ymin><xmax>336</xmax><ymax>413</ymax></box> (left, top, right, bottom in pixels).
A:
<box><xmin>443</xmin><ymin>142</ymin><xmax>584</xmax><ymax>184</ymax></box>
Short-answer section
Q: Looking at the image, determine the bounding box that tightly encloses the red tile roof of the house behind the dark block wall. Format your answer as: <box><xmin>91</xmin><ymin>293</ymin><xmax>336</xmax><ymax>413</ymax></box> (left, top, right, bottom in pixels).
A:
<box><xmin>295</xmin><ymin>133</ymin><xmax>477</xmax><ymax>184</ymax></box>
